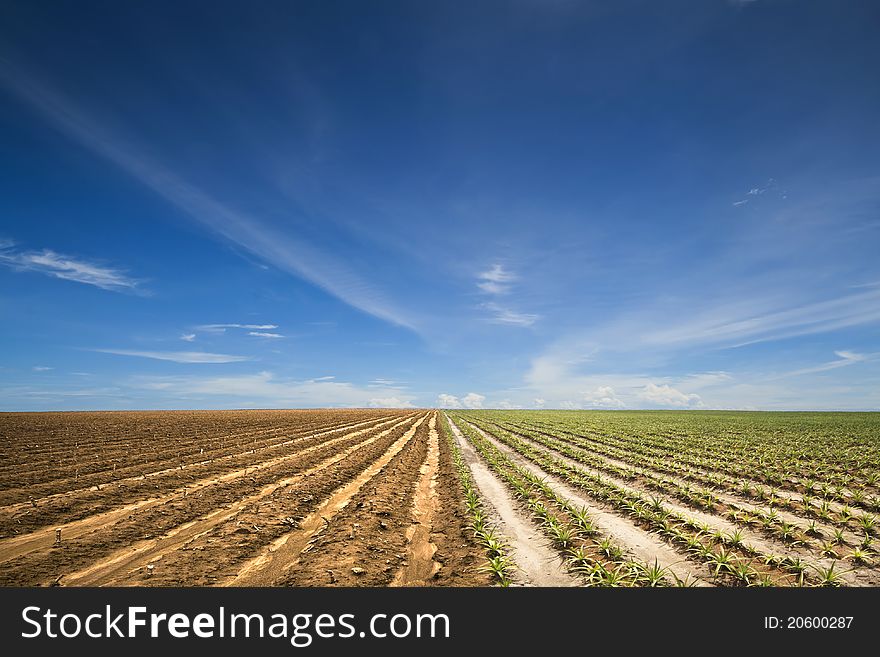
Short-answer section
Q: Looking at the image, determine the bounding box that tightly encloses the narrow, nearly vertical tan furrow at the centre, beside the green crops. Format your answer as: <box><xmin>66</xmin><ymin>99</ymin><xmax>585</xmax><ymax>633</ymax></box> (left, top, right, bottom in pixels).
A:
<box><xmin>391</xmin><ymin>413</ymin><xmax>440</xmax><ymax>586</ymax></box>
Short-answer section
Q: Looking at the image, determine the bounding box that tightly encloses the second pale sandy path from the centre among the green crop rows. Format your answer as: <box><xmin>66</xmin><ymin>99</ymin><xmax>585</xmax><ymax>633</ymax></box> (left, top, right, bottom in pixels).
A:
<box><xmin>460</xmin><ymin>424</ymin><xmax>714</xmax><ymax>586</ymax></box>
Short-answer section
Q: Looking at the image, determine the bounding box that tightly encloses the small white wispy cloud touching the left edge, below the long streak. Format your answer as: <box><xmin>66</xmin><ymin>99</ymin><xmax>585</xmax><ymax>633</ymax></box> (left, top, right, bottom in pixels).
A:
<box><xmin>0</xmin><ymin>240</ymin><xmax>139</xmax><ymax>292</ymax></box>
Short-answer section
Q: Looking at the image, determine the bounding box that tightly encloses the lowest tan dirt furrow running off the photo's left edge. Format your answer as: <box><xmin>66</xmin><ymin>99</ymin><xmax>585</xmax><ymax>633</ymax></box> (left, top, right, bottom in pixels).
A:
<box><xmin>0</xmin><ymin>418</ymin><xmax>409</xmax><ymax>563</ymax></box>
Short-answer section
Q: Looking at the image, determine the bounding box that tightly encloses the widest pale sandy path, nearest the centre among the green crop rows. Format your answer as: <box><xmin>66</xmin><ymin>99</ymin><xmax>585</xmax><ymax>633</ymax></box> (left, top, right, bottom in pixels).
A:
<box><xmin>447</xmin><ymin>416</ymin><xmax>583</xmax><ymax>587</ymax></box>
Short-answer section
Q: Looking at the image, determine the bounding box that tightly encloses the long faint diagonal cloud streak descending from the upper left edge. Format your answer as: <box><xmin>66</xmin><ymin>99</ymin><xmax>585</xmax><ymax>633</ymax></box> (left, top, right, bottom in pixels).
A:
<box><xmin>0</xmin><ymin>60</ymin><xmax>415</xmax><ymax>329</ymax></box>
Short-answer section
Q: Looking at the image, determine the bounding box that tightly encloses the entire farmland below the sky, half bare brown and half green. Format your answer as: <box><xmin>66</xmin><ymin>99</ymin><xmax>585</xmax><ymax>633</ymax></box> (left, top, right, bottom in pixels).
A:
<box><xmin>0</xmin><ymin>409</ymin><xmax>880</xmax><ymax>586</ymax></box>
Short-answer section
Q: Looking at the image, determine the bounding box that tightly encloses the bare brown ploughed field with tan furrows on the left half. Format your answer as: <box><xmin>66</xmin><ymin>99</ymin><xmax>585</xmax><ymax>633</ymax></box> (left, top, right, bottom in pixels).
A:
<box><xmin>0</xmin><ymin>409</ymin><xmax>490</xmax><ymax>586</ymax></box>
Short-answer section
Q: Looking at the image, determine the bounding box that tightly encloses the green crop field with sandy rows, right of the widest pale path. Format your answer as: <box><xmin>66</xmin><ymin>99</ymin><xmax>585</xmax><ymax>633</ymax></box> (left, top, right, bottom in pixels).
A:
<box><xmin>448</xmin><ymin>410</ymin><xmax>880</xmax><ymax>586</ymax></box>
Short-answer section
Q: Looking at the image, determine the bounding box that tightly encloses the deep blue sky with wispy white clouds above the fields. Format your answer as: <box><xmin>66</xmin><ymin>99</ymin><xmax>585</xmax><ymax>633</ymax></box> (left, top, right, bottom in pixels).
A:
<box><xmin>0</xmin><ymin>0</ymin><xmax>880</xmax><ymax>410</ymax></box>
